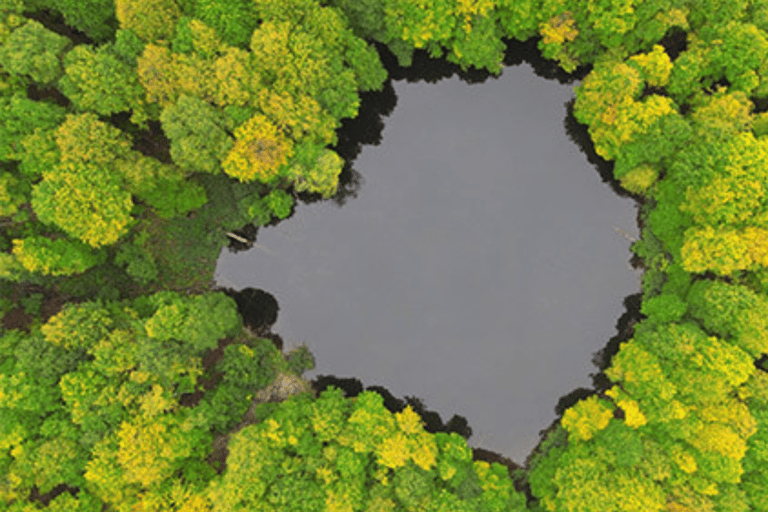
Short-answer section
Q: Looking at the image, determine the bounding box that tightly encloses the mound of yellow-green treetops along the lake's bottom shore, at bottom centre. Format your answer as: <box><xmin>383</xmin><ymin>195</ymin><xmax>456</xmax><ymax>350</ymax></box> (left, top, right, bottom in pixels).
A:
<box><xmin>208</xmin><ymin>388</ymin><xmax>524</xmax><ymax>512</ymax></box>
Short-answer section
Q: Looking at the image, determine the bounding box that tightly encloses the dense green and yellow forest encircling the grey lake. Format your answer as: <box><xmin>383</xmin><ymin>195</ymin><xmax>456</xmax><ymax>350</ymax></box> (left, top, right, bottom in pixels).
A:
<box><xmin>0</xmin><ymin>0</ymin><xmax>768</xmax><ymax>512</ymax></box>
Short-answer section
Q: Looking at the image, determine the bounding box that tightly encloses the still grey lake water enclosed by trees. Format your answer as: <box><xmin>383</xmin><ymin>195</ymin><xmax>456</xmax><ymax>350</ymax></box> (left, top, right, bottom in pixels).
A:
<box><xmin>216</xmin><ymin>49</ymin><xmax>640</xmax><ymax>463</ymax></box>
